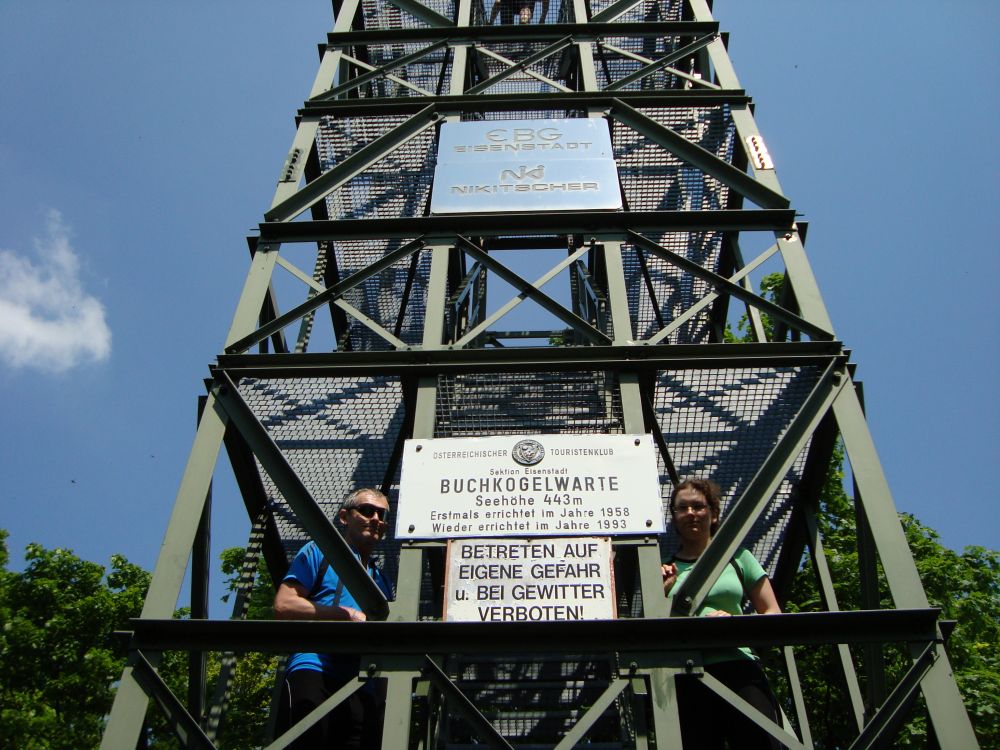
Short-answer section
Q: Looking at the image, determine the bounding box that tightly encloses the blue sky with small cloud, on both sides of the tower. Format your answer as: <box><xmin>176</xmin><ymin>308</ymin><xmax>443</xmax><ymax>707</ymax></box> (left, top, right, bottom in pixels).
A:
<box><xmin>0</xmin><ymin>0</ymin><xmax>1000</xmax><ymax>604</ymax></box>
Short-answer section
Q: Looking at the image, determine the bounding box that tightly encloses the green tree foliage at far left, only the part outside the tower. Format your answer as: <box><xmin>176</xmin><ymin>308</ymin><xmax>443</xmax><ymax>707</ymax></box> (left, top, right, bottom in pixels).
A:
<box><xmin>0</xmin><ymin>530</ymin><xmax>149</xmax><ymax>748</ymax></box>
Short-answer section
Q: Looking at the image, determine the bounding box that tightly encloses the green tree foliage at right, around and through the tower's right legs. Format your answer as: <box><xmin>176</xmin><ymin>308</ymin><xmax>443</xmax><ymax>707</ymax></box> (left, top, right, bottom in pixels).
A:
<box><xmin>786</xmin><ymin>448</ymin><xmax>1000</xmax><ymax>748</ymax></box>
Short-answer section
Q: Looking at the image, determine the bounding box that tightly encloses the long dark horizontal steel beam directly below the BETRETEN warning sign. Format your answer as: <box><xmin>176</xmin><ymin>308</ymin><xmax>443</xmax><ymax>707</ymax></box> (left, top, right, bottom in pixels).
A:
<box><xmin>121</xmin><ymin>607</ymin><xmax>940</xmax><ymax>663</ymax></box>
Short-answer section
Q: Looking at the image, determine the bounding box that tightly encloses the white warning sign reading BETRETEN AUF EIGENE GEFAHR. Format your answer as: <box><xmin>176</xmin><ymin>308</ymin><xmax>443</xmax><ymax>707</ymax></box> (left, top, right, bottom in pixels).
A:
<box><xmin>444</xmin><ymin>537</ymin><xmax>617</xmax><ymax>622</ymax></box>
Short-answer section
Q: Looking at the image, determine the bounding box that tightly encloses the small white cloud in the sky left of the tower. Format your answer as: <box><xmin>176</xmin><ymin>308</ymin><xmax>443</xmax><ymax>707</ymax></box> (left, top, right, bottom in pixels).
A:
<box><xmin>0</xmin><ymin>211</ymin><xmax>111</xmax><ymax>372</ymax></box>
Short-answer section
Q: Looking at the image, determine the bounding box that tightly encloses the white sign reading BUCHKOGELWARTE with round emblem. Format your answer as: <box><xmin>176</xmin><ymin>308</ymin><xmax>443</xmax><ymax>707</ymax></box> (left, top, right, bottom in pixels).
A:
<box><xmin>396</xmin><ymin>435</ymin><xmax>664</xmax><ymax>539</ymax></box>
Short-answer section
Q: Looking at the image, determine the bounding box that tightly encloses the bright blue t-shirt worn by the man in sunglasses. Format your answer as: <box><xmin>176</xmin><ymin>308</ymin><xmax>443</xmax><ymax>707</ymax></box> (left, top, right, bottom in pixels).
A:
<box><xmin>282</xmin><ymin>542</ymin><xmax>392</xmax><ymax>682</ymax></box>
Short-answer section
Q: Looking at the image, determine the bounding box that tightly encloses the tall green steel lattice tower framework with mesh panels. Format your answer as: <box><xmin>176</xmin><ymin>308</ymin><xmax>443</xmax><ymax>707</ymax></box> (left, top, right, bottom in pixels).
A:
<box><xmin>104</xmin><ymin>0</ymin><xmax>976</xmax><ymax>748</ymax></box>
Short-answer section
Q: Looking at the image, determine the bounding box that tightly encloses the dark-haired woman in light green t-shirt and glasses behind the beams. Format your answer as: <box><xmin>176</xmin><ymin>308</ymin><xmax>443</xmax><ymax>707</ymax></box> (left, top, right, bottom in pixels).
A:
<box><xmin>662</xmin><ymin>479</ymin><xmax>782</xmax><ymax>750</ymax></box>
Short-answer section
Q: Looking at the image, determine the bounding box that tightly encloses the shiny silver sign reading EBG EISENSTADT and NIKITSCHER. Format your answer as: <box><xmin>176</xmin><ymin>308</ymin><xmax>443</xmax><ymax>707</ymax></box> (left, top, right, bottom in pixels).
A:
<box><xmin>431</xmin><ymin>118</ymin><xmax>622</xmax><ymax>214</ymax></box>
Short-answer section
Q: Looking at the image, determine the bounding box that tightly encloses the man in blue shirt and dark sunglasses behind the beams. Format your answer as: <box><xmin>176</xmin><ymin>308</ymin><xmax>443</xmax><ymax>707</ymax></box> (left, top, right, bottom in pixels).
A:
<box><xmin>274</xmin><ymin>487</ymin><xmax>392</xmax><ymax>749</ymax></box>
